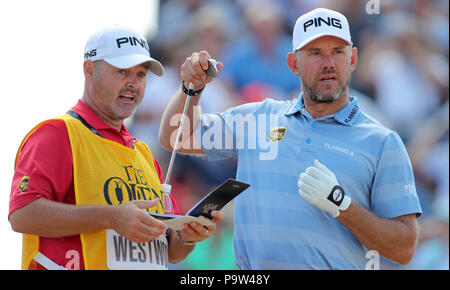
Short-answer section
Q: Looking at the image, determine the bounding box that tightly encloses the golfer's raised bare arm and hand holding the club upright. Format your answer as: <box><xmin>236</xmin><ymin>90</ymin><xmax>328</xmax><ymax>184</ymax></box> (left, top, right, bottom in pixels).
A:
<box><xmin>159</xmin><ymin>51</ymin><xmax>223</xmax><ymax>154</ymax></box>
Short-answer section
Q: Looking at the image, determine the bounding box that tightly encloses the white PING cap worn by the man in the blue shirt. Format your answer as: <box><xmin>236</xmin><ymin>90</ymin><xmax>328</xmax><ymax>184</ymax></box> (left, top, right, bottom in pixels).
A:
<box><xmin>292</xmin><ymin>8</ymin><xmax>353</xmax><ymax>51</ymax></box>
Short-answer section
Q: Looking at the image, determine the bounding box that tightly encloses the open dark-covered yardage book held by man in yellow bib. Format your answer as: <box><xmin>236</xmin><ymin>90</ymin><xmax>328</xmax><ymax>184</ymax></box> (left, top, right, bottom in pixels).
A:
<box><xmin>149</xmin><ymin>178</ymin><xmax>250</xmax><ymax>230</ymax></box>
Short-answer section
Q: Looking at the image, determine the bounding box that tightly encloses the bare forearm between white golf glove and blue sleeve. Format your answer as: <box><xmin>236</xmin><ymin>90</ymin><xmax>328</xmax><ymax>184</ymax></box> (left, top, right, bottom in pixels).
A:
<box><xmin>337</xmin><ymin>201</ymin><xmax>418</xmax><ymax>264</ymax></box>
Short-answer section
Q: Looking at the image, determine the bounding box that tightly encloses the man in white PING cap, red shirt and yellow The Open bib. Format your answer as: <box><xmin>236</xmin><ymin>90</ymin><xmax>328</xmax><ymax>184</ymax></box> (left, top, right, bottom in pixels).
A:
<box><xmin>9</xmin><ymin>25</ymin><xmax>223</xmax><ymax>269</ymax></box>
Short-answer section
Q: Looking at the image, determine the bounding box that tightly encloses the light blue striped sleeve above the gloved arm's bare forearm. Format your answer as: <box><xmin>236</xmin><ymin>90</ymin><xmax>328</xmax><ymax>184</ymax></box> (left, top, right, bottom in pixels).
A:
<box><xmin>371</xmin><ymin>132</ymin><xmax>422</xmax><ymax>218</ymax></box>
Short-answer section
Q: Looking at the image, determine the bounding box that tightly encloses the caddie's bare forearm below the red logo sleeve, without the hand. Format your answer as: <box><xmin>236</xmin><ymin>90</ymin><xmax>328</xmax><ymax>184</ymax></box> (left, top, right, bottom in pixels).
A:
<box><xmin>10</xmin><ymin>198</ymin><xmax>111</xmax><ymax>237</ymax></box>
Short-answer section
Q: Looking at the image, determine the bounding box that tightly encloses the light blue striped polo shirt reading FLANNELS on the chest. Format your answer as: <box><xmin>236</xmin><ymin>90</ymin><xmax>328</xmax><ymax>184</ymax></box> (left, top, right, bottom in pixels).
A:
<box><xmin>196</xmin><ymin>95</ymin><xmax>422</xmax><ymax>269</ymax></box>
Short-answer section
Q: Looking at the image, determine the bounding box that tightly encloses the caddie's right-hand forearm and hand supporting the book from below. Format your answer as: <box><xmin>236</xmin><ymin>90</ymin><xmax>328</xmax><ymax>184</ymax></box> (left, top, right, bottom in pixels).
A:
<box><xmin>169</xmin><ymin>211</ymin><xmax>223</xmax><ymax>263</ymax></box>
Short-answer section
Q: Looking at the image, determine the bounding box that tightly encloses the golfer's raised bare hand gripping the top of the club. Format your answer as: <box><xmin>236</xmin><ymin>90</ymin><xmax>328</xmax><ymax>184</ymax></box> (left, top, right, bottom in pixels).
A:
<box><xmin>181</xmin><ymin>51</ymin><xmax>223</xmax><ymax>91</ymax></box>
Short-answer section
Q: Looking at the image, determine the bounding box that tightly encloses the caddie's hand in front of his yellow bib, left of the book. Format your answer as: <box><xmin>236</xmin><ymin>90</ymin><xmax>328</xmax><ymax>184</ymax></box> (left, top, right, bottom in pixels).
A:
<box><xmin>111</xmin><ymin>199</ymin><xmax>167</xmax><ymax>243</ymax></box>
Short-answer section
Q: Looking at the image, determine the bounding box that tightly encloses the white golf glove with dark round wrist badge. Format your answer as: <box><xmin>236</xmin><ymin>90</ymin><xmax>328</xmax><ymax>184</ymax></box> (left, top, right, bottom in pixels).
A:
<box><xmin>298</xmin><ymin>159</ymin><xmax>352</xmax><ymax>218</ymax></box>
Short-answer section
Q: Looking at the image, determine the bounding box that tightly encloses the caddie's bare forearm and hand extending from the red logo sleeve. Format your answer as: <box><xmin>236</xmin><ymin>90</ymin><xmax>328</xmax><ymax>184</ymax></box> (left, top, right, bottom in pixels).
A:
<box><xmin>9</xmin><ymin>198</ymin><xmax>166</xmax><ymax>243</ymax></box>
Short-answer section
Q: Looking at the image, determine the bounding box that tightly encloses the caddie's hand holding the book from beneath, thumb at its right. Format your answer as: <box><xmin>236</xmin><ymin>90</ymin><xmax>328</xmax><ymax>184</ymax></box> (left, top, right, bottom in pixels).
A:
<box><xmin>180</xmin><ymin>210</ymin><xmax>223</xmax><ymax>242</ymax></box>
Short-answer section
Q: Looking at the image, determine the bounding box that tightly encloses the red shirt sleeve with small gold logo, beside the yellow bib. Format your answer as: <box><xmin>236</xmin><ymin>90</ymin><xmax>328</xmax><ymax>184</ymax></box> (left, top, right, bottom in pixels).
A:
<box><xmin>9</xmin><ymin>120</ymin><xmax>75</xmax><ymax>218</ymax></box>
